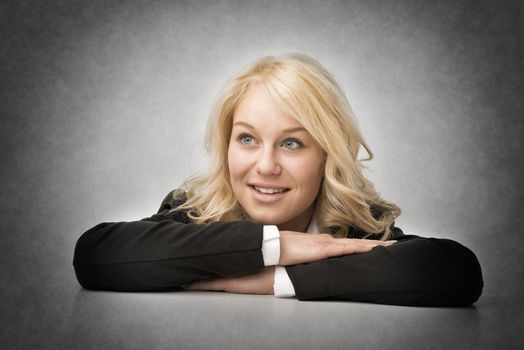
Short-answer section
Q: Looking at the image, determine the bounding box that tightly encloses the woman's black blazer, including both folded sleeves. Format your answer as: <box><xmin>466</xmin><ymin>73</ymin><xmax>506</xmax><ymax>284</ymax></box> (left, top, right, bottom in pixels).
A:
<box><xmin>73</xmin><ymin>192</ymin><xmax>483</xmax><ymax>306</ymax></box>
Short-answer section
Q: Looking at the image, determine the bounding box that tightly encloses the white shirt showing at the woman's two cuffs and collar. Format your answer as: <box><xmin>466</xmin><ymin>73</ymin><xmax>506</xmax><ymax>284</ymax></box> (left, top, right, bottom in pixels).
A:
<box><xmin>262</xmin><ymin>215</ymin><xmax>320</xmax><ymax>298</ymax></box>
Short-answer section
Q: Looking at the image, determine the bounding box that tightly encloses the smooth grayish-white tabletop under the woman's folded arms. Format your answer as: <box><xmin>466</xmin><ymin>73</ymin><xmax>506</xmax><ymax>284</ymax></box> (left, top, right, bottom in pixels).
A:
<box><xmin>10</xmin><ymin>287</ymin><xmax>524</xmax><ymax>349</ymax></box>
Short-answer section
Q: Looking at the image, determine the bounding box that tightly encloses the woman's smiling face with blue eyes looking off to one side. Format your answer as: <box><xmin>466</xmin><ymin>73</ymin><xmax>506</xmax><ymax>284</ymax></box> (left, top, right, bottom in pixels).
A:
<box><xmin>228</xmin><ymin>85</ymin><xmax>325</xmax><ymax>232</ymax></box>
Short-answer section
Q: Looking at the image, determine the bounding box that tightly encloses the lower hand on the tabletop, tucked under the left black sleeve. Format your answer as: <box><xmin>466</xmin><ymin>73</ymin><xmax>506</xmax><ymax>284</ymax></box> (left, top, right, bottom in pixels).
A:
<box><xmin>184</xmin><ymin>266</ymin><xmax>275</xmax><ymax>295</ymax></box>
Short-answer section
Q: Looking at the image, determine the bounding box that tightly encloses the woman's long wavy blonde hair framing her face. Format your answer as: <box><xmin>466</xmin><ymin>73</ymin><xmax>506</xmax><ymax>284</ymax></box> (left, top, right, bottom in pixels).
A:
<box><xmin>173</xmin><ymin>53</ymin><xmax>400</xmax><ymax>239</ymax></box>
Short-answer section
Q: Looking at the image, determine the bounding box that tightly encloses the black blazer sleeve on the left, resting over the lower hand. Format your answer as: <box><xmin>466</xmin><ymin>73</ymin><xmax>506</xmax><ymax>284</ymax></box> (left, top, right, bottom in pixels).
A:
<box><xmin>73</xmin><ymin>192</ymin><xmax>264</xmax><ymax>291</ymax></box>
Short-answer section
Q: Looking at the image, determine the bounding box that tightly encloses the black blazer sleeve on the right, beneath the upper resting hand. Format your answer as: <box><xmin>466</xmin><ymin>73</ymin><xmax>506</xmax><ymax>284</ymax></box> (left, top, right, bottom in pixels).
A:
<box><xmin>286</xmin><ymin>228</ymin><xmax>484</xmax><ymax>306</ymax></box>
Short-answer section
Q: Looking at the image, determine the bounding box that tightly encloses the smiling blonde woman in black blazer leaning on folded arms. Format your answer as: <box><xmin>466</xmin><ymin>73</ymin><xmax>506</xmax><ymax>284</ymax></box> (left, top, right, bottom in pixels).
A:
<box><xmin>74</xmin><ymin>54</ymin><xmax>483</xmax><ymax>305</ymax></box>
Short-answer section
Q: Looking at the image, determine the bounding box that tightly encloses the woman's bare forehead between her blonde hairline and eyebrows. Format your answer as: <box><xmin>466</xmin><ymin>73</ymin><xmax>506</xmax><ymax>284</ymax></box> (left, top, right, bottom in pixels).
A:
<box><xmin>233</xmin><ymin>84</ymin><xmax>302</xmax><ymax>127</ymax></box>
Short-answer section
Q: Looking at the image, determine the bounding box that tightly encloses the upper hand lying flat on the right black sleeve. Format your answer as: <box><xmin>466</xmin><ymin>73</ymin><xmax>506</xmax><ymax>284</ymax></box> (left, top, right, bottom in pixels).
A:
<box><xmin>278</xmin><ymin>231</ymin><xmax>396</xmax><ymax>266</ymax></box>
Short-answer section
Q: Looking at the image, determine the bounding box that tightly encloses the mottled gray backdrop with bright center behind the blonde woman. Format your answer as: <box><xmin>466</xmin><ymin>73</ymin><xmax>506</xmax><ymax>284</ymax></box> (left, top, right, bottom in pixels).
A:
<box><xmin>0</xmin><ymin>0</ymin><xmax>524</xmax><ymax>347</ymax></box>
